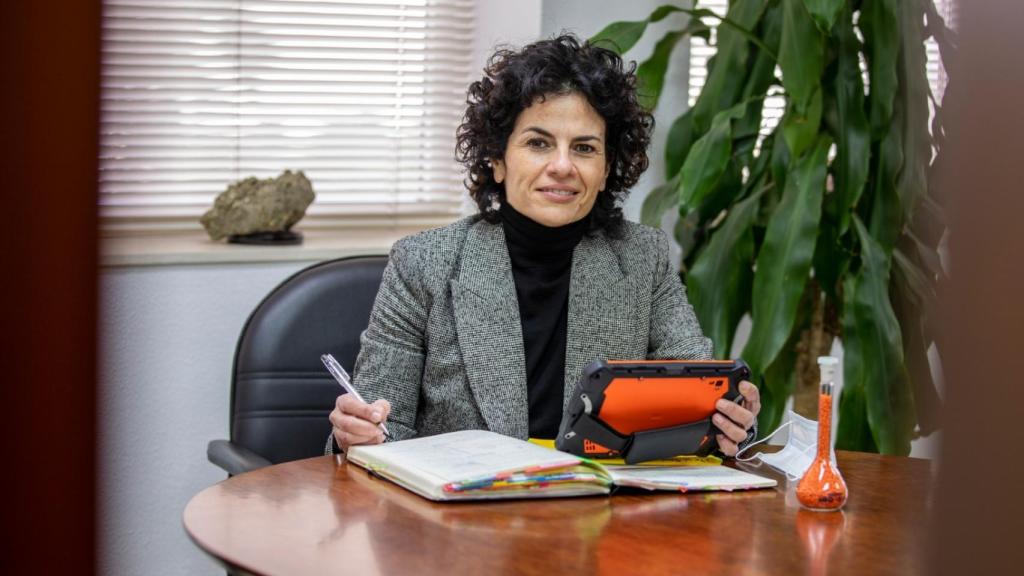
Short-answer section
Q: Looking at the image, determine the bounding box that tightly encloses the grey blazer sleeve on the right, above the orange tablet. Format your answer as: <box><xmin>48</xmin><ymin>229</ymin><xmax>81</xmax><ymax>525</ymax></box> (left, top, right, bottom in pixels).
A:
<box><xmin>647</xmin><ymin>231</ymin><xmax>714</xmax><ymax>360</ymax></box>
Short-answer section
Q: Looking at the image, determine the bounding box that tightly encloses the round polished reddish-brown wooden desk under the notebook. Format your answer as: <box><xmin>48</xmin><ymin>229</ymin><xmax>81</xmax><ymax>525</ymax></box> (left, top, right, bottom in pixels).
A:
<box><xmin>184</xmin><ymin>452</ymin><xmax>933</xmax><ymax>576</ymax></box>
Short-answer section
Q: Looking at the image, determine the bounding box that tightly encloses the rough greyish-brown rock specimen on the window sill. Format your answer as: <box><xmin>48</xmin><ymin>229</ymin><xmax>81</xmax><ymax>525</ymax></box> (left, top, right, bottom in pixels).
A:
<box><xmin>200</xmin><ymin>170</ymin><xmax>316</xmax><ymax>240</ymax></box>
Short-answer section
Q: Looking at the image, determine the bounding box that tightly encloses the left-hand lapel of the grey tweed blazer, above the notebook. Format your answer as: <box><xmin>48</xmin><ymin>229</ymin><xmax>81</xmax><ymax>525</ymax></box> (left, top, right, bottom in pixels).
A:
<box><xmin>451</xmin><ymin>220</ymin><xmax>529</xmax><ymax>439</ymax></box>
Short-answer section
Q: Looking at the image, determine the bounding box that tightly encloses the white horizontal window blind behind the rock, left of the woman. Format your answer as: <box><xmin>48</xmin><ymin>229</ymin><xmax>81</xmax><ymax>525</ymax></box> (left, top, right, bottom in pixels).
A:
<box><xmin>99</xmin><ymin>0</ymin><xmax>473</xmax><ymax>232</ymax></box>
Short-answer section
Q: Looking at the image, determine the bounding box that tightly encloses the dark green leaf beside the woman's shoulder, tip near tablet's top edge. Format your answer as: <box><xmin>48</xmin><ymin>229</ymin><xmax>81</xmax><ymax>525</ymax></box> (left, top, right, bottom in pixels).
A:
<box><xmin>686</xmin><ymin>190</ymin><xmax>761</xmax><ymax>358</ymax></box>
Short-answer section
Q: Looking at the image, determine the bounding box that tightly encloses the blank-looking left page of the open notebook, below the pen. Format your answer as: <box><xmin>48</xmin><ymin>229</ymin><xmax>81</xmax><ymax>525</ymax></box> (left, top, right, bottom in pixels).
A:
<box><xmin>349</xmin><ymin>430</ymin><xmax>579</xmax><ymax>484</ymax></box>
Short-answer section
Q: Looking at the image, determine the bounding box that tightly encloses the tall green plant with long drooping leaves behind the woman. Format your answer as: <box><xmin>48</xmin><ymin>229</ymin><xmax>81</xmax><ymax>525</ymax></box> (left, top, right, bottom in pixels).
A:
<box><xmin>591</xmin><ymin>0</ymin><xmax>955</xmax><ymax>454</ymax></box>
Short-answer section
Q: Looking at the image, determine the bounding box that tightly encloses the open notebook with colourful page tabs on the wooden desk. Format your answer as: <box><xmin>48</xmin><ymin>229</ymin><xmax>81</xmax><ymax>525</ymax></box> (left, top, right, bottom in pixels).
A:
<box><xmin>348</xmin><ymin>430</ymin><xmax>776</xmax><ymax>500</ymax></box>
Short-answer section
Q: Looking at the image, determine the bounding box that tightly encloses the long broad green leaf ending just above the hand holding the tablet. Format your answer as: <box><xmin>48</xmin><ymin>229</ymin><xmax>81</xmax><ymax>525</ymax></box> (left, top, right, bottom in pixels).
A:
<box><xmin>743</xmin><ymin>134</ymin><xmax>831</xmax><ymax>373</ymax></box>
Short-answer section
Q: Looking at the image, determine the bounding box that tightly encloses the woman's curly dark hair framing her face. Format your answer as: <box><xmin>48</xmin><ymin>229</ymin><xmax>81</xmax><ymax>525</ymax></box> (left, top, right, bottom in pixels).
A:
<box><xmin>456</xmin><ymin>33</ymin><xmax>654</xmax><ymax>236</ymax></box>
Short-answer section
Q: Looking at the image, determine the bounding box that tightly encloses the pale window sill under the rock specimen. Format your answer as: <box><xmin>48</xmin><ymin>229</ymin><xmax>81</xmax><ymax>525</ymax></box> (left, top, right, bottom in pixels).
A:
<box><xmin>100</xmin><ymin>227</ymin><xmax>422</xmax><ymax>268</ymax></box>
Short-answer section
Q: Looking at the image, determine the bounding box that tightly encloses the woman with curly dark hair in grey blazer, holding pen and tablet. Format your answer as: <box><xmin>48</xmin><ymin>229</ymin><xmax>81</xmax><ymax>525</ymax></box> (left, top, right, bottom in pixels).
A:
<box><xmin>329</xmin><ymin>35</ymin><xmax>760</xmax><ymax>455</ymax></box>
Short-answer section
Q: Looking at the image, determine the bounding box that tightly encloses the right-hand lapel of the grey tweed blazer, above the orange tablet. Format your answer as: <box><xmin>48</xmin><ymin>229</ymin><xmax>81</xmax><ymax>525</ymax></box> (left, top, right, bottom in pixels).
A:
<box><xmin>562</xmin><ymin>235</ymin><xmax>635</xmax><ymax>410</ymax></box>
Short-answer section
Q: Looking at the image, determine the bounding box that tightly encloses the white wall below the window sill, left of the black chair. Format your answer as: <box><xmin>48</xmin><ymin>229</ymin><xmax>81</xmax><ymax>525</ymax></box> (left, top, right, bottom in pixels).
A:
<box><xmin>97</xmin><ymin>260</ymin><xmax>311</xmax><ymax>575</ymax></box>
